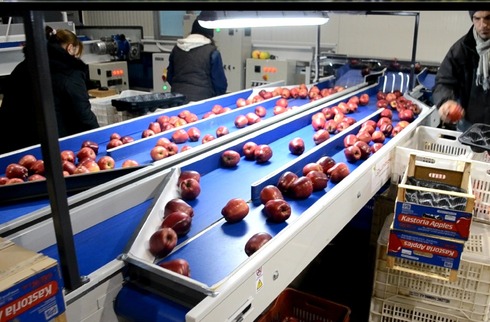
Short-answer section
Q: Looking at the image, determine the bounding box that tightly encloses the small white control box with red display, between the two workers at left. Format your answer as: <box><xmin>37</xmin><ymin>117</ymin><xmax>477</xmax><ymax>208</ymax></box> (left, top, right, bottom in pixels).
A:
<box><xmin>88</xmin><ymin>61</ymin><xmax>129</xmax><ymax>92</ymax></box>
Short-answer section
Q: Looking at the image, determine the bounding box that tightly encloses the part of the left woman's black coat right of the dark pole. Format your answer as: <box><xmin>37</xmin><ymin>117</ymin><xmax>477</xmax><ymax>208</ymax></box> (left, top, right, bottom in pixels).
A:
<box><xmin>48</xmin><ymin>43</ymin><xmax>99</xmax><ymax>137</ymax></box>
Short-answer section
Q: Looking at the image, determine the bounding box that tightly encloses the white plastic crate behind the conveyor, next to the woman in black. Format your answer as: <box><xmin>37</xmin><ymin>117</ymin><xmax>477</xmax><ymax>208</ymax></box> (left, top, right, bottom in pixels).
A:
<box><xmin>90</xmin><ymin>90</ymin><xmax>151</xmax><ymax>126</ymax></box>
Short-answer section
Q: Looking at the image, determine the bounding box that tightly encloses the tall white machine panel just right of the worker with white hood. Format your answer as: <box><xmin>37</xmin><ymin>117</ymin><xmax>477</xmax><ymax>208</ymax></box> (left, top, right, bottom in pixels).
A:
<box><xmin>214</xmin><ymin>28</ymin><xmax>252</xmax><ymax>92</ymax></box>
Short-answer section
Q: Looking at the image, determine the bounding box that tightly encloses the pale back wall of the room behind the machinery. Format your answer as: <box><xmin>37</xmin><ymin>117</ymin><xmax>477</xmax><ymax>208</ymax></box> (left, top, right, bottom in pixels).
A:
<box><xmin>83</xmin><ymin>11</ymin><xmax>471</xmax><ymax>63</ymax></box>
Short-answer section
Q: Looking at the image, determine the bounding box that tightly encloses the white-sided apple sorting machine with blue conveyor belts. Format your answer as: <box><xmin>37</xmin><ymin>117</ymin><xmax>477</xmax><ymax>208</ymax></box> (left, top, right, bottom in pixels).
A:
<box><xmin>0</xmin><ymin>64</ymin><xmax>433</xmax><ymax>321</ymax></box>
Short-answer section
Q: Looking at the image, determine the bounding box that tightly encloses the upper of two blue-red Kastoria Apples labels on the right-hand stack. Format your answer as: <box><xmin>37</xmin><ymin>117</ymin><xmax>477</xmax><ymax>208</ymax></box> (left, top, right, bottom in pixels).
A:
<box><xmin>393</xmin><ymin>201</ymin><xmax>472</xmax><ymax>240</ymax></box>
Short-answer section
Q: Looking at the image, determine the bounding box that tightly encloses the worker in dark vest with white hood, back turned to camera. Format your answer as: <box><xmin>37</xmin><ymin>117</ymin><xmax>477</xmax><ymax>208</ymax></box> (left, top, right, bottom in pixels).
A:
<box><xmin>167</xmin><ymin>20</ymin><xmax>228</xmax><ymax>102</ymax></box>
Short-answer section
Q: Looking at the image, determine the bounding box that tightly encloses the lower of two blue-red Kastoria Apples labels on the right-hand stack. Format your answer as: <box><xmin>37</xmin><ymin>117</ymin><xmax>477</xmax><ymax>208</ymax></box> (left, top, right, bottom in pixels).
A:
<box><xmin>388</xmin><ymin>230</ymin><xmax>464</xmax><ymax>269</ymax></box>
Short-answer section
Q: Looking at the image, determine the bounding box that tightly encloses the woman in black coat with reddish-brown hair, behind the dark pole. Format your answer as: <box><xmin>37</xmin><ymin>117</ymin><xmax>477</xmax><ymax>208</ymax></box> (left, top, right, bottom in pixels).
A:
<box><xmin>0</xmin><ymin>27</ymin><xmax>99</xmax><ymax>154</ymax></box>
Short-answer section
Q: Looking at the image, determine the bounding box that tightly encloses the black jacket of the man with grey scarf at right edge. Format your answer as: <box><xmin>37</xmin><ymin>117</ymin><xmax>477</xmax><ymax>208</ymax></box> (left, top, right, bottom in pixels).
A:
<box><xmin>432</xmin><ymin>27</ymin><xmax>490</xmax><ymax>124</ymax></box>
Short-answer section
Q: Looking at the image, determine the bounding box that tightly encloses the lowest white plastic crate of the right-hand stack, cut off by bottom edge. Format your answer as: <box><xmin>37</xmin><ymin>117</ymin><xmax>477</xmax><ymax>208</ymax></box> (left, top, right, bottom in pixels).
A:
<box><xmin>369</xmin><ymin>297</ymin><xmax>478</xmax><ymax>322</ymax></box>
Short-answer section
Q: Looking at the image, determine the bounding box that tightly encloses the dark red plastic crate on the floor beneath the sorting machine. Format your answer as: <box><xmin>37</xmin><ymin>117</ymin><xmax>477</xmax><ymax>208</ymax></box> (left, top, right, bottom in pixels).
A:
<box><xmin>256</xmin><ymin>288</ymin><xmax>351</xmax><ymax>322</ymax></box>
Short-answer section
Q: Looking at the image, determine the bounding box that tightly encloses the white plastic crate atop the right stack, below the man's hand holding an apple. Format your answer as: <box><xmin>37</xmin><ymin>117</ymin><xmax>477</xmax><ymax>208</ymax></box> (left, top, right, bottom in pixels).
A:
<box><xmin>392</xmin><ymin>126</ymin><xmax>473</xmax><ymax>183</ymax></box>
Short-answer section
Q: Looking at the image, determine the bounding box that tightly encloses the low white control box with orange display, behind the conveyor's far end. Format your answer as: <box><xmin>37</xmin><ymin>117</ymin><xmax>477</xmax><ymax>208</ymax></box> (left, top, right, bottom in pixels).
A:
<box><xmin>245</xmin><ymin>58</ymin><xmax>305</xmax><ymax>88</ymax></box>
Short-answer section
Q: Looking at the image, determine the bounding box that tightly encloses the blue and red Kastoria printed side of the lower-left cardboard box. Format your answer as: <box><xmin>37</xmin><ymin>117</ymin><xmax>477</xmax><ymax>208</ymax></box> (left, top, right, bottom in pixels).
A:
<box><xmin>0</xmin><ymin>265</ymin><xmax>65</xmax><ymax>322</ymax></box>
